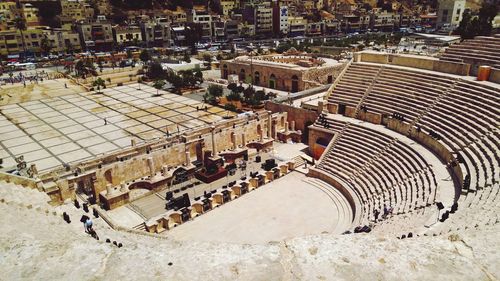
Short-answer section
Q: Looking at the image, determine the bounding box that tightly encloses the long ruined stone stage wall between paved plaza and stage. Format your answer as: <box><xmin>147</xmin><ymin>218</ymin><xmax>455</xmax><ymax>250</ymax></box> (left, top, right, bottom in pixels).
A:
<box><xmin>49</xmin><ymin>112</ymin><xmax>288</xmax><ymax>201</ymax></box>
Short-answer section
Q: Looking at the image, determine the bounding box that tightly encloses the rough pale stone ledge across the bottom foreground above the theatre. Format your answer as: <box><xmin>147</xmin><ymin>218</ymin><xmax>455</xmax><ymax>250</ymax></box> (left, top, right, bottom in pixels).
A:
<box><xmin>0</xmin><ymin>196</ymin><xmax>500</xmax><ymax>281</ymax></box>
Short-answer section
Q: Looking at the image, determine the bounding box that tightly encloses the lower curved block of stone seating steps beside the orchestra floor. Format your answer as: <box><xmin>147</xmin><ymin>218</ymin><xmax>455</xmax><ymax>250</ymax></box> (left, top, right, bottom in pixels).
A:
<box><xmin>318</xmin><ymin>118</ymin><xmax>437</xmax><ymax>223</ymax></box>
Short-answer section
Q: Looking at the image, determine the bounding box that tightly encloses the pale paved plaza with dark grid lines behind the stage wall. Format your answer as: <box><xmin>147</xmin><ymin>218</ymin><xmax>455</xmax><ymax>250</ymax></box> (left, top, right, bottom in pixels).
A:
<box><xmin>0</xmin><ymin>84</ymin><xmax>234</xmax><ymax>171</ymax></box>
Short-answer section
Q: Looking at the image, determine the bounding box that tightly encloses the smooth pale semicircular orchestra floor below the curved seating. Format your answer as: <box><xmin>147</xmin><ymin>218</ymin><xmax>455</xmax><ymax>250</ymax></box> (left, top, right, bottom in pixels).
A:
<box><xmin>165</xmin><ymin>172</ymin><xmax>352</xmax><ymax>244</ymax></box>
